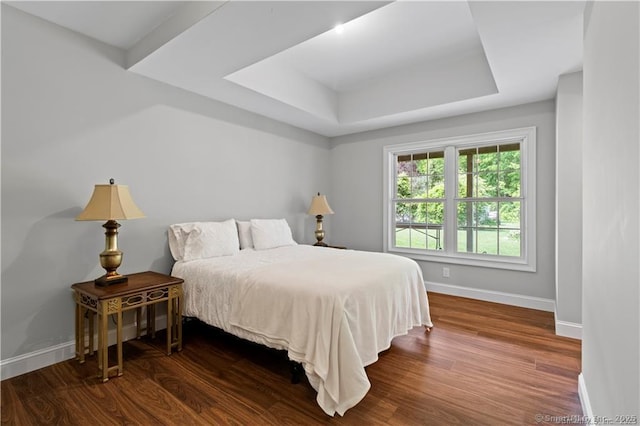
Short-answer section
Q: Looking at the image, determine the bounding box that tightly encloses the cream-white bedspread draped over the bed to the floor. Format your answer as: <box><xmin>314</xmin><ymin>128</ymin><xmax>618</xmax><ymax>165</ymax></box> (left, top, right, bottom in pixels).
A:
<box><xmin>172</xmin><ymin>245</ymin><xmax>432</xmax><ymax>415</ymax></box>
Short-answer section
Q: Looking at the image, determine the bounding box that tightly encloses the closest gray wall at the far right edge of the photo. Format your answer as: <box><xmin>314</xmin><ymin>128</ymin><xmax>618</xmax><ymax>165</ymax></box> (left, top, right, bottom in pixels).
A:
<box><xmin>582</xmin><ymin>2</ymin><xmax>640</xmax><ymax>419</ymax></box>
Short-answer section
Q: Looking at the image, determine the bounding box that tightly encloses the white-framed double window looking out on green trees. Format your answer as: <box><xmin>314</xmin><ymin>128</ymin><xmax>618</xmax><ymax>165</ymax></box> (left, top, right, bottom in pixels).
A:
<box><xmin>384</xmin><ymin>127</ymin><xmax>535</xmax><ymax>271</ymax></box>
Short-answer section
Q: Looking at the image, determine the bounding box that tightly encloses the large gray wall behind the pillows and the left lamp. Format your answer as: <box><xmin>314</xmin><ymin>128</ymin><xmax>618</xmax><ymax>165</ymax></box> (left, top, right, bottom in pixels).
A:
<box><xmin>1</xmin><ymin>4</ymin><xmax>330</xmax><ymax>360</ymax></box>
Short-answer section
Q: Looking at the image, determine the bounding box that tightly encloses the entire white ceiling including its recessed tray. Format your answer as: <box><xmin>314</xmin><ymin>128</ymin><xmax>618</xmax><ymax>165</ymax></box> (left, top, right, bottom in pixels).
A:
<box><xmin>6</xmin><ymin>0</ymin><xmax>584</xmax><ymax>137</ymax></box>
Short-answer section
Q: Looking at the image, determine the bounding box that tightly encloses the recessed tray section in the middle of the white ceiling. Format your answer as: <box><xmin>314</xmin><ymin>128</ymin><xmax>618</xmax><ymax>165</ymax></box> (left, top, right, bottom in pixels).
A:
<box><xmin>224</xmin><ymin>1</ymin><xmax>498</xmax><ymax>126</ymax></box>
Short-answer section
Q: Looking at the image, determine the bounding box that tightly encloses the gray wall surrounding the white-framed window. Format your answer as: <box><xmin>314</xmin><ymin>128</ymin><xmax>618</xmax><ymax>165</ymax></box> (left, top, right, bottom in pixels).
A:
<box><xmin>327</xmin><ymin>101</ymin><xmax>555</xmax><ymax>299</ymax></box>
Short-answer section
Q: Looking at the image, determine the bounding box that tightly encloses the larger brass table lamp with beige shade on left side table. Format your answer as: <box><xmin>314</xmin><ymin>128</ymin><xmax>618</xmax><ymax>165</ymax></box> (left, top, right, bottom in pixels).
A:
<box><xmin>76</xmin><ymin>179</ymin><xmax>144</xmax><ymax>286</ymax></box>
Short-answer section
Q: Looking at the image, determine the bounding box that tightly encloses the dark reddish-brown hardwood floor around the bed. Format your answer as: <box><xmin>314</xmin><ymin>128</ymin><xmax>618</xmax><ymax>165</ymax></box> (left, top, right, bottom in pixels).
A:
<box><xmin>0</xmin><ymin>293</ymin><xmax>582</xmax><ymax>425</ymax></box>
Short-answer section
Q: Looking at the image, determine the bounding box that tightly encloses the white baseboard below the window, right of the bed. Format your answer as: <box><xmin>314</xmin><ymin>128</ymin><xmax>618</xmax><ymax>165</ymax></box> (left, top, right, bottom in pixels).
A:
<box><xmin>424</xmin><ymin>281</ymin><xmax>556</xmax><ymax>312</ymax></box>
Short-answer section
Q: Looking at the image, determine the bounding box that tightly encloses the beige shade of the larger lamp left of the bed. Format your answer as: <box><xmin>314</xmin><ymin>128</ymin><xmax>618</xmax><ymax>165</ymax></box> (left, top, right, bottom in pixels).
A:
<box><xmin>76</xmin><ymin>183</ymin><xmax>144</xmax><ymax>220</ymax></box>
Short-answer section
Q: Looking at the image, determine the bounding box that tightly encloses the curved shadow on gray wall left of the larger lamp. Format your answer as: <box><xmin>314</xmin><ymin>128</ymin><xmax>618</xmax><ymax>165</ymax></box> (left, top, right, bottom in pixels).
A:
<box><xmin>2</xmin><ymin>207</ymin><xmax>98</xmax><ymax>359</ymax></box>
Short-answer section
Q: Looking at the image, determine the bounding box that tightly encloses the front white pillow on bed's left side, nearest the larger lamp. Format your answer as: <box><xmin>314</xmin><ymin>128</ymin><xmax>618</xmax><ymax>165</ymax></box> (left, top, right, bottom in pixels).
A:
<box><xmin>183</xmin><ymin>219</ymin><xmax>240</xmax><ymax>261</ymax></box>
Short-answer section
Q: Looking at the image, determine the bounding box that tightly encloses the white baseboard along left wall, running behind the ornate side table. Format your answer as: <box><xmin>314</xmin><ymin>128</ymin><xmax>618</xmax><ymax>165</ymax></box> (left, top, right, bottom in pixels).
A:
<box><xmin>0</xmin><ymin>315</ymin><xmax>167</xmax><ymax>380</ymax></box>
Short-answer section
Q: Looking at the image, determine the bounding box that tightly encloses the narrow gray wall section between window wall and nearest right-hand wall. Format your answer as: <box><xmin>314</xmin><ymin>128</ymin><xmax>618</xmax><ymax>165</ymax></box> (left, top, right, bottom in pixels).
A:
<box><xmin>555</xmin><ymin>72</ymin><xmax>583</xmax><ymax>324</ymax></box>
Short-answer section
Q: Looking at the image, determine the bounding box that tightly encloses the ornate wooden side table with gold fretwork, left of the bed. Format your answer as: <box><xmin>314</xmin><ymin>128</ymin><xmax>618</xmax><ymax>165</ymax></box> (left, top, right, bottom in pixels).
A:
<box><xmin>71</xmin><ymin>271</ymin><xmax>183</xmax><ymax>382</ymax></box>
